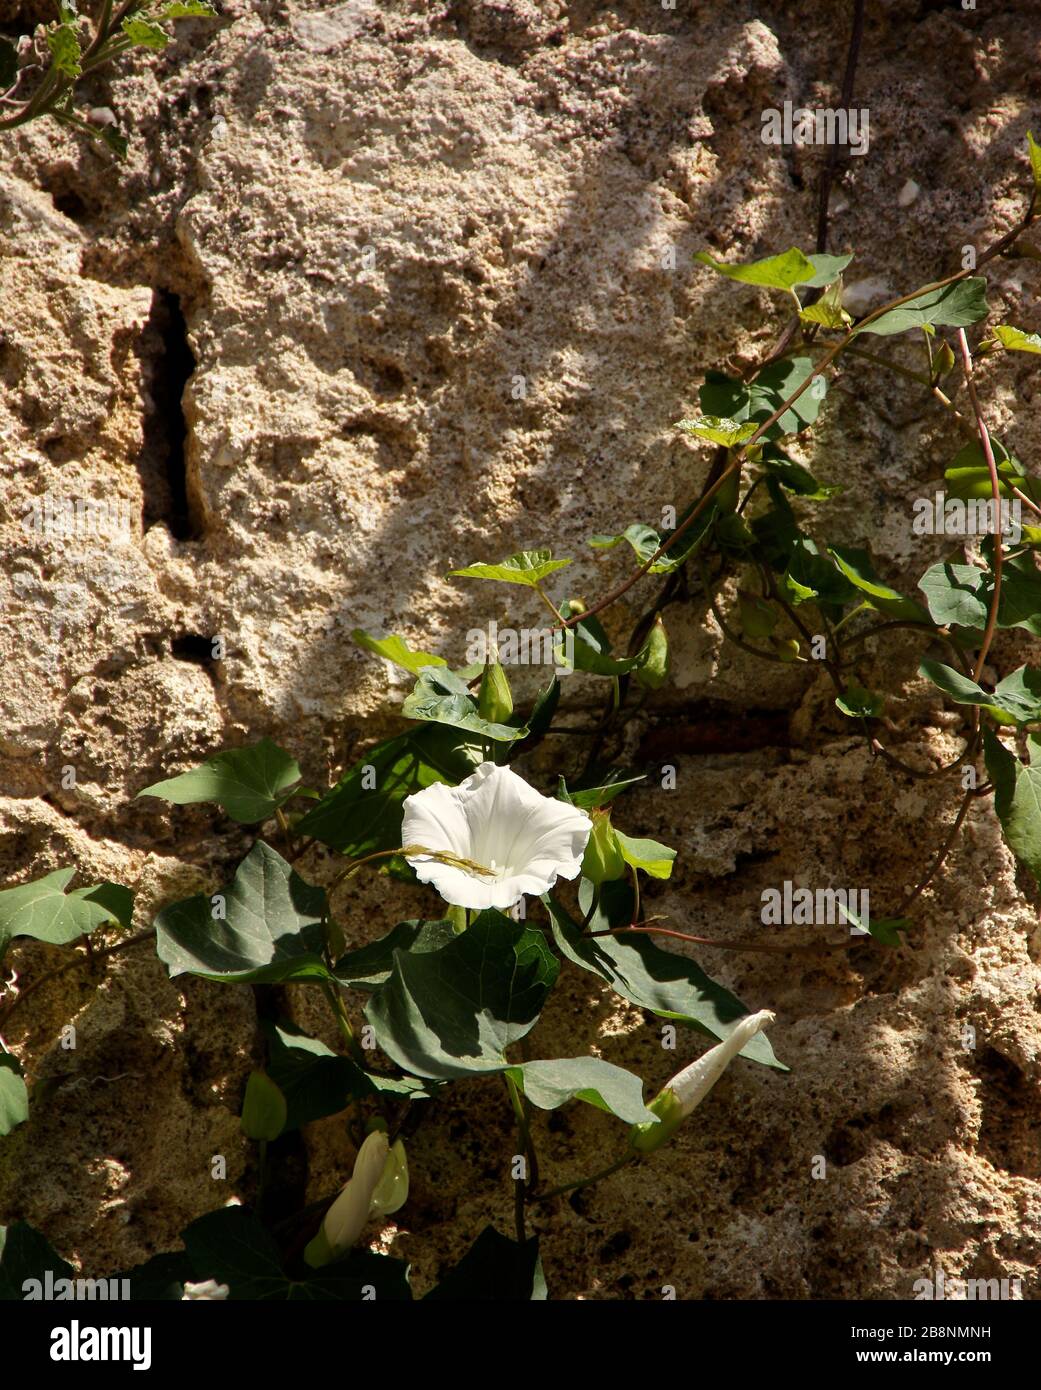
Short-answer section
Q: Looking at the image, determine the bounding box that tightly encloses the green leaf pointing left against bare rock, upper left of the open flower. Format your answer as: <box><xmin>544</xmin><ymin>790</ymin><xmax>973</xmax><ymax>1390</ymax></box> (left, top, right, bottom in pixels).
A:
<box><xmin>138</xmin><ymin>738</ymin><xmax>300</xmax><ymax>826</ymax></box>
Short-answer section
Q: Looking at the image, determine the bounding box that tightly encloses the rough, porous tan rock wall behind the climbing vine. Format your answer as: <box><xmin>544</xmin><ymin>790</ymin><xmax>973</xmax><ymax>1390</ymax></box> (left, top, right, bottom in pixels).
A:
<box><xmin>0</xmin><ymin>0</ymin><xmax>1041</xmax><ymax>1298</ymax></box>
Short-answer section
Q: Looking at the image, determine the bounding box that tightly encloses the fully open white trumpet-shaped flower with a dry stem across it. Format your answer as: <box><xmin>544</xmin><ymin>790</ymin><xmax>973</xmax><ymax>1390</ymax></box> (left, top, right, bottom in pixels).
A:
<box><xmin>402</xmin><ymin>763</ymin><xmax>592</xmax><ymax>909</ymax></box>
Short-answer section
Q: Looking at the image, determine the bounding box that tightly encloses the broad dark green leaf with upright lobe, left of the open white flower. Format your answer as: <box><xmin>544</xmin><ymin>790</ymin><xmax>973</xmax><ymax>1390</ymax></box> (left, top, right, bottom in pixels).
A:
<box><xmin>156</xmin><ymin>840</ymin><xmax>334</xmax><ymax>984</ymax></box>
